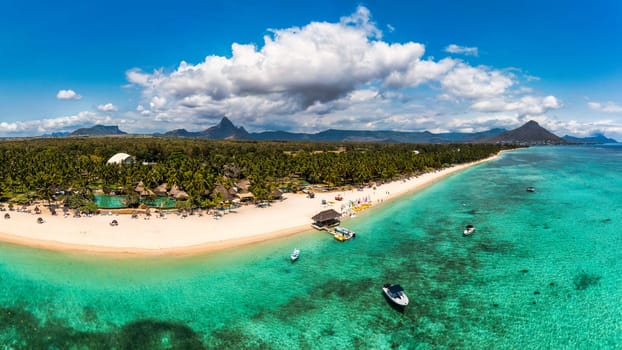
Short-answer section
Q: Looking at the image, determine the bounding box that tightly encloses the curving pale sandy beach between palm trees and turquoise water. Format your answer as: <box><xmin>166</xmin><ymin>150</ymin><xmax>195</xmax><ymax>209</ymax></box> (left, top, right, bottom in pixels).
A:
<box><xmin>0</xmin><ymin>157</ymin><xmax>494</xmax><ymax>255</ymax></box>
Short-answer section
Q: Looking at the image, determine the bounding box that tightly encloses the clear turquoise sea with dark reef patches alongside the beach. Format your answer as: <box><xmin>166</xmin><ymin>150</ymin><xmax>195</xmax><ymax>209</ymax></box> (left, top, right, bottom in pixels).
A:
<box><xmin>0</xmin><ymin>146</ymin><xmax>622</xmax><ymax>349</ymax></box>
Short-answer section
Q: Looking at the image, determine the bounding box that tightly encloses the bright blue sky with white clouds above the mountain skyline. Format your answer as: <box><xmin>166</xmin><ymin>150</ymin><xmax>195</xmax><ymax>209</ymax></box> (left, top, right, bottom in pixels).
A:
<box><xmin>0</xmin><ymin>0</ymin><xmax>622</xmax><ymax>138</ymax></box>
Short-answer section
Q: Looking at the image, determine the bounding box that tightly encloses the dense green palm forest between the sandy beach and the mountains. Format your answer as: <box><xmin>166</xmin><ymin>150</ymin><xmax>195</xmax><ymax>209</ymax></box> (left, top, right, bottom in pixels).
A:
<box><xmin>0</xmin><ymin>137</ymin><xmax>516</xmax><ymax>210</ymax></box>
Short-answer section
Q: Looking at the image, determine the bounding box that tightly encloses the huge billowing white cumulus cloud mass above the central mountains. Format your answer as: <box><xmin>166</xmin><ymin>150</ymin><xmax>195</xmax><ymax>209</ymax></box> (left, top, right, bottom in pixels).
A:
<box><xmin>119</xmin><ymin>6</ymin><xmax>572</xmax><ymax>132</ymax></box>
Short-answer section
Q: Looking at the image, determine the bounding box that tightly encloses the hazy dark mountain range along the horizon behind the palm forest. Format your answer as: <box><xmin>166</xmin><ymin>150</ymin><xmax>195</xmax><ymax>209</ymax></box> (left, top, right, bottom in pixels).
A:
<box><xmin>63</xmin><ymin>117</ymin><xmax>617</xmax><ymax>145</ymax></box>
